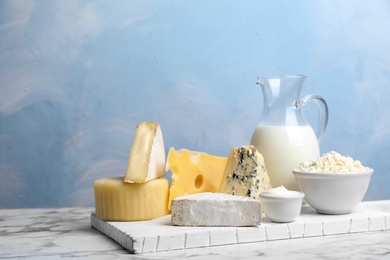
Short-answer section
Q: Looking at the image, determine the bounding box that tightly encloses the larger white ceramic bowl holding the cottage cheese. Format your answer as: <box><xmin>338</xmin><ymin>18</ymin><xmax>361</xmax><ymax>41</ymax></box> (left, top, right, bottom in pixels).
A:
<box><xmin>293</xmin><ymin>168</ymin><xmax>374</xmax><ymax>214</ymax></box>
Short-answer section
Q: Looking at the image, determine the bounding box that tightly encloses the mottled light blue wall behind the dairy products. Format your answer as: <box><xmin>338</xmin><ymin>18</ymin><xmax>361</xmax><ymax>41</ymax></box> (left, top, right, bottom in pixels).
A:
<box><xmin>0</xmin><ymin>0</ymin><xmax>390</xmax><ymax>208</ymax></box>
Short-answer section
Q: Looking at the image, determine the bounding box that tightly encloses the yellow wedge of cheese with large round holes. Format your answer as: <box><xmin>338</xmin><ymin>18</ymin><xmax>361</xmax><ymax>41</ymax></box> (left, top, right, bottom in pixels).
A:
<box><xmin>166</xmin><ymin>147</ymin><xmax>227</xmax><ymax>209</ymax></box>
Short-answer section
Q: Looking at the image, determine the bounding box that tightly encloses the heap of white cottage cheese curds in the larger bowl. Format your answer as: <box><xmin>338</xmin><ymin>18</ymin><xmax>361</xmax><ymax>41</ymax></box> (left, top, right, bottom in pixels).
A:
<box><xmin>294</xmin><ymin>151</ymin><xmax>369</xmax><ymax>173</ymax></box>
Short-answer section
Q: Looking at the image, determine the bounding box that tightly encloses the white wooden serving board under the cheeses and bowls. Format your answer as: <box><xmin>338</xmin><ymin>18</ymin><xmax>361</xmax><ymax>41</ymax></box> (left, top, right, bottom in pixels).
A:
<box><xmin>91</xmin><ymin>201</ymin><xmax>390</xmax><ymax>254</ymax></box>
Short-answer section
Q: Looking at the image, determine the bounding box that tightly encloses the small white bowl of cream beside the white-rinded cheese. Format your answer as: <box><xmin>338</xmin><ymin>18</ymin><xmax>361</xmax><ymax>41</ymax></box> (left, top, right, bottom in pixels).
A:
<box><xmin>260</xmin><ymin>188</ymin><xmax>305</xmax><ymax>223</ymax></box>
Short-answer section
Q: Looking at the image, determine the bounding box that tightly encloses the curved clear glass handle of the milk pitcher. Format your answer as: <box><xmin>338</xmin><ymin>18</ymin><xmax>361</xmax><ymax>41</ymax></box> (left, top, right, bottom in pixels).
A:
<box><xmin>301</xmin><ymin>95</ymin><xmax>329</xmax><ymax>144</ymax></box>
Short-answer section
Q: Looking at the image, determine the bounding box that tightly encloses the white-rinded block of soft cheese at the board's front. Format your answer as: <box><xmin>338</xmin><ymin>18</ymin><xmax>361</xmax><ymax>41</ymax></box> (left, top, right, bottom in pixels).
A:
<box><xmin>171</xmin><ymin>192</ymin><xmax>262</xmax><ymax>227</ymax></box>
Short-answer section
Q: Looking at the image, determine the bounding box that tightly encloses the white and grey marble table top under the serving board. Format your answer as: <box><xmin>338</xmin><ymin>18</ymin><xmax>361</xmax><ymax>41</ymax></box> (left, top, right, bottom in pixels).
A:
<box><xmin>0</xmin><ymin>204</ymin><xmax>390</xmax><ymax>260</ymax></box>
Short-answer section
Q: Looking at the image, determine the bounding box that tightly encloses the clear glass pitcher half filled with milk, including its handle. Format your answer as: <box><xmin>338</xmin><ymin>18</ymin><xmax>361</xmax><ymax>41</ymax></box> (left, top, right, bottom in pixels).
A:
<box><xmin>251</xmin><ymin>75</ymin><xmax>328</xmax><ymax>191</ymax></box>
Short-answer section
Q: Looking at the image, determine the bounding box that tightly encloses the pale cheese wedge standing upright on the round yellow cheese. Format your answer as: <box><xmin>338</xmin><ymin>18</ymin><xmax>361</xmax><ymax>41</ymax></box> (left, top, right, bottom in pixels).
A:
<box><xmin>124</xmin><ymin>122</ymin><xmax>165</xmax><ymax>183</ymax></box>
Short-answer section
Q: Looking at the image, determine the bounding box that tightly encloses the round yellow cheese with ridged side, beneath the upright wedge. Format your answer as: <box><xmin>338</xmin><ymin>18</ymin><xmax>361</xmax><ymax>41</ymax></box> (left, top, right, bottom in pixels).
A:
<box><xmin>93</xmin><ymin>177</ymin><xmax>169</xmax><ymax>221</ymax></box>
